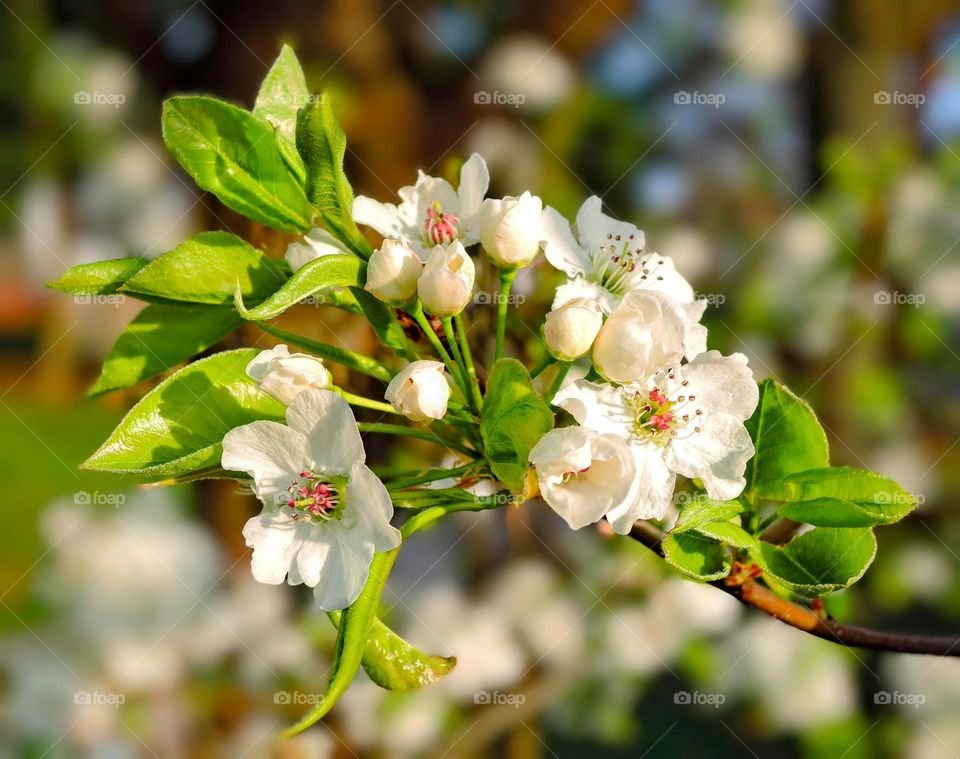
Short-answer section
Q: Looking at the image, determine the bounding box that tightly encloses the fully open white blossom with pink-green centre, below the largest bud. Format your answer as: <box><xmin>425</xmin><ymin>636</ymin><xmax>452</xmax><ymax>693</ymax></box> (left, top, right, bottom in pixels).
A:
<box><xmin>553</xmin><ymin>351</ymin><xmax>759</xmax><ymax>534</ymax></box>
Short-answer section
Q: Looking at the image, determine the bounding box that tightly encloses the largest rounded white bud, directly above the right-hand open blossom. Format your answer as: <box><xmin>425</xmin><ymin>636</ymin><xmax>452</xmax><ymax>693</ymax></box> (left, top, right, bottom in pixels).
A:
<box><xmin>593</xmin><ymin>290</ymin><xmax>686</xmax><ymax>382</ymax></box>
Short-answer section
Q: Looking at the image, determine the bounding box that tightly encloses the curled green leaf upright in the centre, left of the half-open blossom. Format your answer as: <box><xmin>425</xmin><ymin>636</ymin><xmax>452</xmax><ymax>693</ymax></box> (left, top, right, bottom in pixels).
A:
<box><xmin>480</xmin><ymin>358</ymin><xmax>553</xmax><ymax>493</ymax></box>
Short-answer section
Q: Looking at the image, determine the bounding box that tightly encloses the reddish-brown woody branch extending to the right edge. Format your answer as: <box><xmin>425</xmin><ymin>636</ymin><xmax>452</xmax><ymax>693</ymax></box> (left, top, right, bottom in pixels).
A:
<box><xmin>630</xmin><ymin>522</ymin><xmax>960</xmax><ymax>657</ymax></box>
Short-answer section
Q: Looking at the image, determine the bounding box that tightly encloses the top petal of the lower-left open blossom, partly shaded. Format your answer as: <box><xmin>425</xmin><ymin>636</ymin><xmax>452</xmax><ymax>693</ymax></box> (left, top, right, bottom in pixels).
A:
<box><xmin>287</xmin><ymin>389</ymin><xmax>366</xmax><ymax>474</ymax></box>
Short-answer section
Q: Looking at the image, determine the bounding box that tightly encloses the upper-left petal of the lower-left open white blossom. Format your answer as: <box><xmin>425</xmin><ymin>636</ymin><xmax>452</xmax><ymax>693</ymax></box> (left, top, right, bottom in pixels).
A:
<box><xmin>220</xmin><ymin>422</ymin><xmax>308</xmax><ymax>506</ymax></box>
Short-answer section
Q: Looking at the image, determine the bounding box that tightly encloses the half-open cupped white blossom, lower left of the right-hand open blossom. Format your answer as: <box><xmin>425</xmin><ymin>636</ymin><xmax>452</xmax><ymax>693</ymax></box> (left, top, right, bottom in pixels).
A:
<box><xmin>530</xmin><ymin>427</ymin><xmax>635</xmax><ymax>530</ymax></box>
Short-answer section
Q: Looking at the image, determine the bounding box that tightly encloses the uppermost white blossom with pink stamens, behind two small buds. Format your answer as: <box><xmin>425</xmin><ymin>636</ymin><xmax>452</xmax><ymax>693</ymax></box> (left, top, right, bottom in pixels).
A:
<box><xmin>353</xmin><ymin>153</ymin><xmax>490</xmax><ymax>259</ymax></box>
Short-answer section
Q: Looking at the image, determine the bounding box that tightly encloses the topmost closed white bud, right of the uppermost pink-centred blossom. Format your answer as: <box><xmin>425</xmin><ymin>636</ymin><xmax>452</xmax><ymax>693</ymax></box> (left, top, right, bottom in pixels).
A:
<box><xmin>480</xmin><ymin>192</ymin><xmax>543</xmax><ymax>269</ymax></box>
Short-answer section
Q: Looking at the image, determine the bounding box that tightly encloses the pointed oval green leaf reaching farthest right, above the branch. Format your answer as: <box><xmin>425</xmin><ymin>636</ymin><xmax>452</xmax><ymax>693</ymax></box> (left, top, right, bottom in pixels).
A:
<box><xmin>758</xmin><ymin>467</ymin><xmax>917</xmax><ymax>527</ymax></box>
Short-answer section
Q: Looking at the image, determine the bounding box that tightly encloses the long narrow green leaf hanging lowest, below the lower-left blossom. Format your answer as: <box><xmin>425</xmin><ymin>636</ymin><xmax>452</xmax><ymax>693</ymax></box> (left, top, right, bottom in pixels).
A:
<box><xmin>284</xmin><ymin>548</ymin><xmax>399</xmax><ymax>737</ymax></box>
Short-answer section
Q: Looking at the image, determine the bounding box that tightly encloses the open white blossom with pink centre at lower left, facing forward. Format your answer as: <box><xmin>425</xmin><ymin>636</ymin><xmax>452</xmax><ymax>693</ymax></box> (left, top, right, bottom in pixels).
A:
<box><xmin>221</xmin><ymin>389</ymin><xmax>400</xmax><ymax>611</ymax></box>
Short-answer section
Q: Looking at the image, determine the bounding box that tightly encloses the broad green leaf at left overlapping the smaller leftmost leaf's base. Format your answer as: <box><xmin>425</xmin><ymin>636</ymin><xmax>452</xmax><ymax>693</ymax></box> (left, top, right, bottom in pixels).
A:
<box><xmin>121</xmin><ymin>232</ymin><xmax>286</xmax><ymax>305</ymax></box>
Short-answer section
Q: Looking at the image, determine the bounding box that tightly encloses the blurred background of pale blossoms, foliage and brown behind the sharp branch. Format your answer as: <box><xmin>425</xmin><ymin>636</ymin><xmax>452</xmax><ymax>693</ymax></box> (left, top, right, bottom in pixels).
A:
<box><xmin>0</xmin><ymin>0</ymin><xmax>960</xmax><ymax>759</ymax></box>
